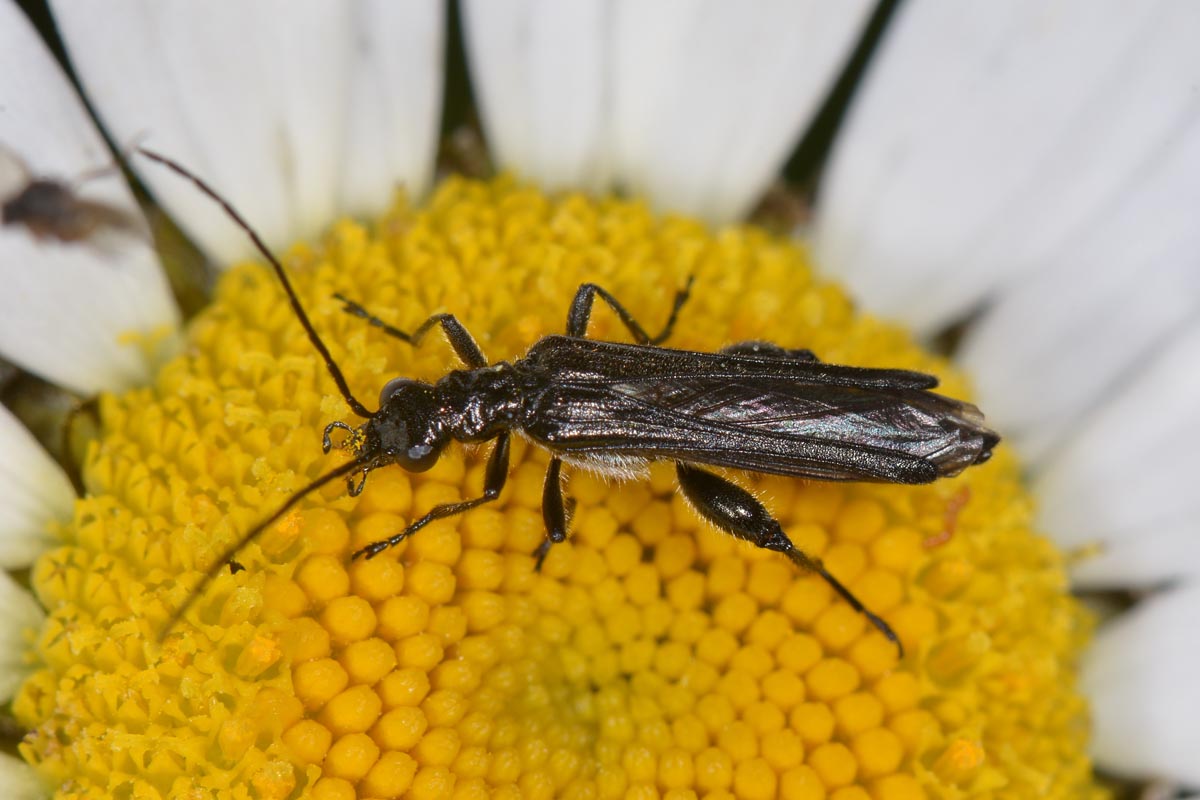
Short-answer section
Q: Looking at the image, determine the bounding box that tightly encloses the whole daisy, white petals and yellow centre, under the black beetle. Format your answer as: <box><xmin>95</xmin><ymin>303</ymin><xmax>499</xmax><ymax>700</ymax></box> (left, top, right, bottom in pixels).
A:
<box><xmin>0</xmin><ymin>0</ymin><xmax>1200</xmax><ymax>800</ymax></box>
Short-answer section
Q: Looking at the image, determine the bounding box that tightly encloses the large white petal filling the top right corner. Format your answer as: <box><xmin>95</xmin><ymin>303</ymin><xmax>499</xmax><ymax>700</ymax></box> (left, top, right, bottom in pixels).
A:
<box><xmin>817</xmin><ymin>0</ymin><xmax>1200</xmax><ymax>332</ymax></box>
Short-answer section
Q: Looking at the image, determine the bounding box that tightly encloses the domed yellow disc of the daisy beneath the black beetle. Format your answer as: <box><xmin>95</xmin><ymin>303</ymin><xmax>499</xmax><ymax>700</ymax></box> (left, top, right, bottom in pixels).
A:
<box><xmin>13</xmin><ymin>178</ymin><xmax>1099</xmax><ymax>800</ymax></box>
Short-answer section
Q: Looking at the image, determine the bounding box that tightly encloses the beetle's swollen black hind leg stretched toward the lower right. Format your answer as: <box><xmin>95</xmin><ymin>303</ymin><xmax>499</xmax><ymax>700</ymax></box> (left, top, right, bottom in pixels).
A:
<box><xmin>676</xmin><ymin>463</ymin><xmax>904</xmax><ymax>657</ymax></box>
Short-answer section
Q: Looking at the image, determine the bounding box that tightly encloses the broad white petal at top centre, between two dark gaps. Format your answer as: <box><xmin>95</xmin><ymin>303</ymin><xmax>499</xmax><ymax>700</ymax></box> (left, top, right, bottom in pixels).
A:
<box><xmin>463</xmin><ymin>0</ymin><xmax>870</xmax><ymax>222</ymax></box>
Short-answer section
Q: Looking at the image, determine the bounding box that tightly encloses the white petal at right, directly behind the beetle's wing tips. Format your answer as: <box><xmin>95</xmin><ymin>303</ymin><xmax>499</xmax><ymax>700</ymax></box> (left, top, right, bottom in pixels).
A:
<box><xmin>961</xmin><ymin>118</ymin><xmax>1200</xmax><ymax>461</ymax></box>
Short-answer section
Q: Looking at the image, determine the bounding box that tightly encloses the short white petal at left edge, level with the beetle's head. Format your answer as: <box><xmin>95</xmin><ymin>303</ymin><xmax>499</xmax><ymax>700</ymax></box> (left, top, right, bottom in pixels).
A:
<box><xmin>0</xmin><ymin>405</ymin><xmax>76</xmax><ymax>570</ymax></box>
